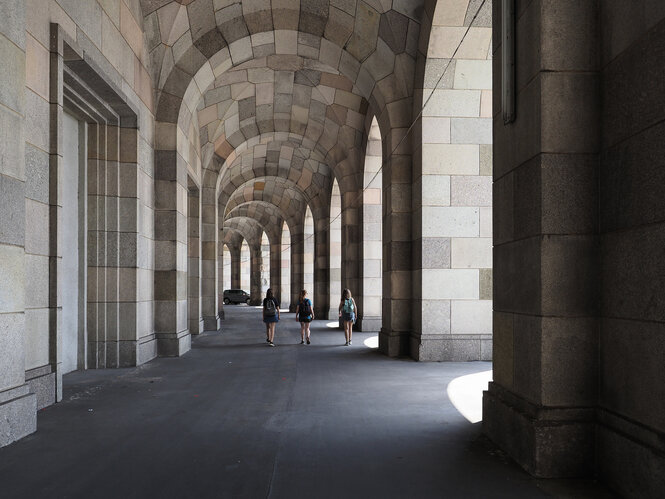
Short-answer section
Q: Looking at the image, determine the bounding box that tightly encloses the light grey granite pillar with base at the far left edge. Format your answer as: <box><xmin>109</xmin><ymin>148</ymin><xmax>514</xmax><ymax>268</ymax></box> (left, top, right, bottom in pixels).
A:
<box><xmin>0</xmin><ymin>2</ymin><xmax>37</xmax><ymax>447</ymax></box>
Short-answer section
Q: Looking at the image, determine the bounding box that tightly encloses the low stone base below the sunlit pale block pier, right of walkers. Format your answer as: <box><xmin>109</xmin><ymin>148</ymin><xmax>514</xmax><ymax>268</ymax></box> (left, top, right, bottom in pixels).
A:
<box><xmin>409</xmin><ymin>334</ymin><xmax>492</xmax><ymax>362</ymax></box>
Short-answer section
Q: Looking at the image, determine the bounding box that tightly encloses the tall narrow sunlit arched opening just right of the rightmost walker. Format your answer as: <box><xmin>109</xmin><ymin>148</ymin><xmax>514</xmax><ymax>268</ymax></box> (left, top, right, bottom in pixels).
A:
<box><xmin>359</xmin><ymin>117</ymin><xmax>383</xmax><ymax>332</ymax></box>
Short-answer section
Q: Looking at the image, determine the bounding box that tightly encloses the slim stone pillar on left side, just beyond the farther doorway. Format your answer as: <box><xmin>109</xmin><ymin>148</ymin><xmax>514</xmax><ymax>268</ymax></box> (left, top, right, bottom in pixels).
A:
<box><xmin>201</xmin><ymin>184</ymin><xmax>218</xmax><ymax>331</ymax></box>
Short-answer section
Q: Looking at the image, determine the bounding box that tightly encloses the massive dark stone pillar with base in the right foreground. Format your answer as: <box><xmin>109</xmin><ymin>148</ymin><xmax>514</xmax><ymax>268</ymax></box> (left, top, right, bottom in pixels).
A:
<box><xmin>483</xmin><ymin>1</ymin><xmax>600</xmax><ymax>477</ymax></box>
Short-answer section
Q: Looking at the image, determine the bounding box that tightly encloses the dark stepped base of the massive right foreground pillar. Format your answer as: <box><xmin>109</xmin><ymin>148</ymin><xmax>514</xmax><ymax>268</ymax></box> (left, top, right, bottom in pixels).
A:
<box><xmin>483</xmin><ymin>382</ymin><xmax>595</xmax><ymax>478</ymax></box>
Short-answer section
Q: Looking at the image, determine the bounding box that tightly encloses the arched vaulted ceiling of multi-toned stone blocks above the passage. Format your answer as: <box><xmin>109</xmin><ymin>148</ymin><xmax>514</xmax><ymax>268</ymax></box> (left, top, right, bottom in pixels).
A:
<box><xmin>141</xmin><ymin>0</ymin><xmax>422</xmax><ymax>235</ymax></box>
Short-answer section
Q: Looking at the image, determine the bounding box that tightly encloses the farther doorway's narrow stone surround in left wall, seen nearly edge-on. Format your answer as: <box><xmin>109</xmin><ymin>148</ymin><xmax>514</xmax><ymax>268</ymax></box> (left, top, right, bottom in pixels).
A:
<box><xmin>187</xmin><ymin>184</ymin><xmax>203</xmax><ymax>334</ymax></box>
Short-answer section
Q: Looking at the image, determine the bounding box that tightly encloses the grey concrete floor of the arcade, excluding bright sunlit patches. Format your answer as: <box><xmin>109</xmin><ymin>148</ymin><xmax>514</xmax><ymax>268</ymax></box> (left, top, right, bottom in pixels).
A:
<box><xmin>0</xmin><ymin>306</ymin><xmax>611</xmax><ymax>499</ymax></box>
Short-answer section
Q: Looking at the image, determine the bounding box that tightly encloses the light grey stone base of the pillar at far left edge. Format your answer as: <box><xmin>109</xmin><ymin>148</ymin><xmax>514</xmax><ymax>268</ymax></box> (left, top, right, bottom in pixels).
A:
<box><xmin>0</xmin><ymin>384</ymin><xmax>37</xmax><ymax>447</ymax></box>
